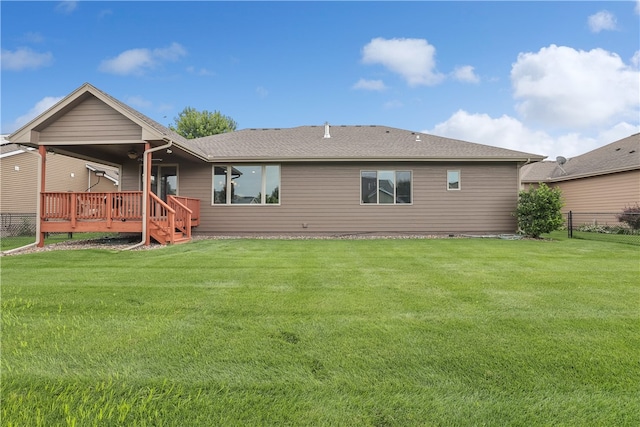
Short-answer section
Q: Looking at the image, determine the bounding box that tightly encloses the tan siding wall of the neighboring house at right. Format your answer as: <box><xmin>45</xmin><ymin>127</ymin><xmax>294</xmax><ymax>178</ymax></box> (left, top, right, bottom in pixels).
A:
<box><xmin>553</xmin><ymin>170</ymin><xmax>640</xmax><ymax>212</ymax></box>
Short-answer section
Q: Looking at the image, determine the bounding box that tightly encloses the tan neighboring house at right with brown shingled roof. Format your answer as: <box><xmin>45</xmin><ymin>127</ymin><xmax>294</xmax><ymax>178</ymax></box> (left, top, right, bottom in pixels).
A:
<box><xmin>522</xmin><ymin>133</ymin><xmax>640</xmax><ymax>217</ymax></box>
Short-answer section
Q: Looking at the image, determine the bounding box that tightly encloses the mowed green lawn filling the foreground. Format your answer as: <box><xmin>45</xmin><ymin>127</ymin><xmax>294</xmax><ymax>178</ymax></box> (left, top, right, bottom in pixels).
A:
<box><xmin>0</xmin><ymin>239</ymin><xmax>640</xmax><ymax>426</ymax></box>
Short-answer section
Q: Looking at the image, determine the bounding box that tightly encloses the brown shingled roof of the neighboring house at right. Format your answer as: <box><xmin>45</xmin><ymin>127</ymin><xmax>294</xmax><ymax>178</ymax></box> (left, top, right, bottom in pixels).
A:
<box><xmin>521</xmin><ymin>133</ymin><xmax>640</xmax><ymax>183</ymax></box>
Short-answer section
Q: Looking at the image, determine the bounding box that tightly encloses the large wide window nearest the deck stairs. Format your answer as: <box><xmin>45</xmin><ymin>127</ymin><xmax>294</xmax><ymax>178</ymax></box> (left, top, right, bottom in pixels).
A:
<box><xmin>213</xmin><ymin>165</ymin><xmax>280</xmax><ymax>205</ymax></box>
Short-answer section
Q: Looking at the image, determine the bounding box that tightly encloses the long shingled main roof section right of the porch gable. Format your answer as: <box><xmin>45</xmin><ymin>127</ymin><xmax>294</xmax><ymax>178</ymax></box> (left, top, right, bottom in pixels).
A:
<box><xmin>187</xmin><ymin>126</ymin><xmax>543</xmax><ymax>161</ymax></box>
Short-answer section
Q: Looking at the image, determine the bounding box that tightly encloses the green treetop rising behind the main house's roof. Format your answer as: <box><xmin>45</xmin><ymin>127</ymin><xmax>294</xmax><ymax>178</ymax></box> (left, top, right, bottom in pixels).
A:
<box><xmin>169</xmin><ymin>107</ymin><xmax>238</xmax><ymax>139</ymax></box>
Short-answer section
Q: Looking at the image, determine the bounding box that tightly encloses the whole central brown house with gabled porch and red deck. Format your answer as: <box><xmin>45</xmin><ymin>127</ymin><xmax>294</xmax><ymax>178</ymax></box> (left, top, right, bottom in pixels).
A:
<box><xmin>9</xmin><ymin>84</ymin><xmax>544</xmax><ymax>243</ymax></box>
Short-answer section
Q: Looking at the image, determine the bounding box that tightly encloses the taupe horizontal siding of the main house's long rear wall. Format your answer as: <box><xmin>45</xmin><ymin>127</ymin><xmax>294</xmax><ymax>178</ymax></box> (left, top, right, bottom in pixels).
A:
<box><xmin>190</xmin><ymin>162</ymin><xmax>518</xmax><ymax>233</ymax></box>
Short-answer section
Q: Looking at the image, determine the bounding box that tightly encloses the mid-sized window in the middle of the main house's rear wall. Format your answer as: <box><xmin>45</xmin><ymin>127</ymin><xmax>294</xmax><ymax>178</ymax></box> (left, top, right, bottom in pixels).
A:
<box><xmin>360</xmin><ymin>170</ymin><xmax>411</xmax><ymax>205</ymax></box>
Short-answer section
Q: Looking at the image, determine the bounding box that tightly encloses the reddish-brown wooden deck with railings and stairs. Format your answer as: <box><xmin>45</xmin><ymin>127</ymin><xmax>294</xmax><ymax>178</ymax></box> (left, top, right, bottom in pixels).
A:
<box><xmin>40</xmin><ymin>191</ymin><xmax>200</xmax><ymax>244</ymax></box>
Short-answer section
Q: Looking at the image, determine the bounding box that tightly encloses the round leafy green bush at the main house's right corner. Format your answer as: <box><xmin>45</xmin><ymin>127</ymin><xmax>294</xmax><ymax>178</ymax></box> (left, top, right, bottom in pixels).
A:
<box><xmin>515</xmin><ymin>183</ymin><xmax>564</xmax><ymax>238</ymax></box>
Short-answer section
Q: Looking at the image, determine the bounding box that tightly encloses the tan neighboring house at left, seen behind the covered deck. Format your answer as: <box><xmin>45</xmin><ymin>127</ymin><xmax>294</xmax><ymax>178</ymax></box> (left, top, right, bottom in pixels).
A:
<box><xmin>0</xmin><ymin>135</ymin><xmax>119</xmax><ymax>215</ymax></box>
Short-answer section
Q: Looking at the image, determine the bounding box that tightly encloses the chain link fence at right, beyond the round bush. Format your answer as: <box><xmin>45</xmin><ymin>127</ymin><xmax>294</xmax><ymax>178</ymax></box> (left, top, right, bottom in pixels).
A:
<box><xmin>567</xmin><ymin>211</ymin><xmax>640</xmax><ymax>246</ymax></box>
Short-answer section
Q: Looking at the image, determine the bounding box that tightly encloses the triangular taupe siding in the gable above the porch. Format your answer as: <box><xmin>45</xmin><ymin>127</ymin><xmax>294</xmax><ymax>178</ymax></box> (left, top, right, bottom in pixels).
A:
<box><xmin>40</xmin><ymin>96</ymin><xmax>142</xmax><ymax>143</ymax></box>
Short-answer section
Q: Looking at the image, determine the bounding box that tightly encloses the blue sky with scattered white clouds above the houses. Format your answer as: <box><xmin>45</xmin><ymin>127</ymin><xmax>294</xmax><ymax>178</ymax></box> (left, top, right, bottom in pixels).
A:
<box><xmin>0</xmin><ymin>1</ymin><xmax>640</xmax><ymax>159</ymax></box>
